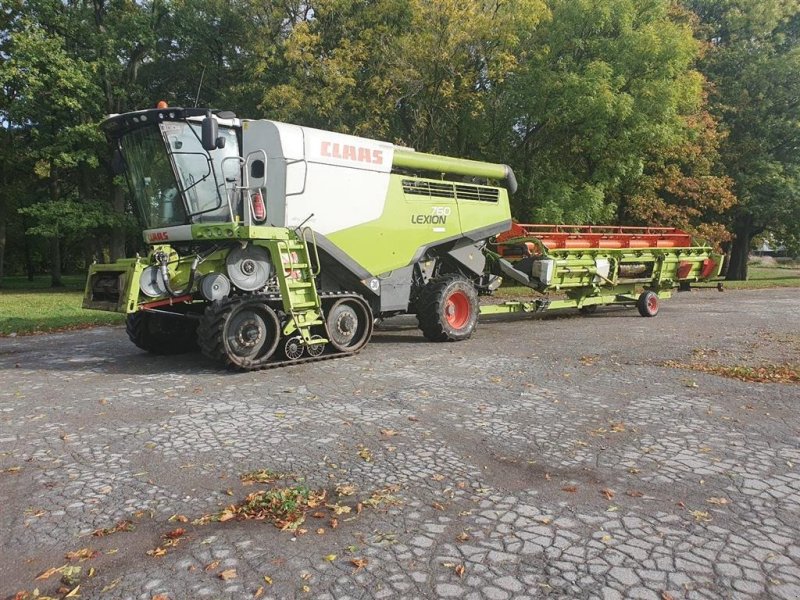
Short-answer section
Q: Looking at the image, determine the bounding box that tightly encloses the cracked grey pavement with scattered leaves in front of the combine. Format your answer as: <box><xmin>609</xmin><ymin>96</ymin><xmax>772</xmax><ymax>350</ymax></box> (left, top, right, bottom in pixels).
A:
<box><xmin>0</xmin><ymin>290</ymin><xmax>800</xmax><ymax>600</ymax></box>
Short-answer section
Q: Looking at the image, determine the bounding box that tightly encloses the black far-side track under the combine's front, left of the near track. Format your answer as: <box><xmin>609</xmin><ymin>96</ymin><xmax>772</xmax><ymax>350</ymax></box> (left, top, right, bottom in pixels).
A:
<box><xmin>125</xmin><ymin>311</ymin><xmax>197</xmax><ymax>355</ymax></box>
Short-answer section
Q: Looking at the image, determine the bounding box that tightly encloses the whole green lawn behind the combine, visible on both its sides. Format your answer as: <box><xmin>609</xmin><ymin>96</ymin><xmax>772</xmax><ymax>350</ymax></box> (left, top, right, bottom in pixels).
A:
<box><xmin>0</xmin><ymin>265</ymin><xmax>800</xmax><ymax>336</ymax></box>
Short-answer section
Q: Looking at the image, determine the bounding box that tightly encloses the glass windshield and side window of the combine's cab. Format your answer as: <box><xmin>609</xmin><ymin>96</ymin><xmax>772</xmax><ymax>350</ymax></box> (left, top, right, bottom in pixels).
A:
<box><xmin>120</xmin><ymin>121</ymin><xmax>239</xmax><ymax>229</ymax></box>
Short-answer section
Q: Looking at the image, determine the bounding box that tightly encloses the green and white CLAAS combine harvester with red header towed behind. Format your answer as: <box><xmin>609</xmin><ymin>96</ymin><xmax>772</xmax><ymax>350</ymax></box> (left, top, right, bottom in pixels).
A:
<box><xmin>84</xmin><ymin>107</ymin><xmax>721</xmax><ymax>370</ymax></box>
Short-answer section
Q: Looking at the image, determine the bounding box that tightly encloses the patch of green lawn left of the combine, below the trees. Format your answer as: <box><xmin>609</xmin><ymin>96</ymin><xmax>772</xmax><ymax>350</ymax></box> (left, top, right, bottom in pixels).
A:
<box><xmin>0</xmin><ymin>275</ymin><xmax>125</xmax><ymax>336</ymax></box>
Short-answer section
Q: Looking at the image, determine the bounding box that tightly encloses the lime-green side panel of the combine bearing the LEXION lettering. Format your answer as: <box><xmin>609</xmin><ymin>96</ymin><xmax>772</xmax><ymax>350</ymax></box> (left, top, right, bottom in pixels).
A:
<box><xmin>328</xmin><ymin>172</ymin><xmax>511</xmax><ymax>275</ymax></box>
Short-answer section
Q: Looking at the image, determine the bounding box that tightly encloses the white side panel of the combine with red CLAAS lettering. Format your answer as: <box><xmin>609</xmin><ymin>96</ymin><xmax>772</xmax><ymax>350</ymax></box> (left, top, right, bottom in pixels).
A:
<box><xmin>242</xmin><ymin>121</ymin><xmax>394</xmax><ymax>234</ymax></box>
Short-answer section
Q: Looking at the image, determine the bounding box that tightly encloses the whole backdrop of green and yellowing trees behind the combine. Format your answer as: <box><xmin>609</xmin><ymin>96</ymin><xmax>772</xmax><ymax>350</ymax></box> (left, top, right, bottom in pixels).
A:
<box><xmin>0</xmin><ymin>0</ymin><xmax>800</xmax><ymax>281</ymax></box>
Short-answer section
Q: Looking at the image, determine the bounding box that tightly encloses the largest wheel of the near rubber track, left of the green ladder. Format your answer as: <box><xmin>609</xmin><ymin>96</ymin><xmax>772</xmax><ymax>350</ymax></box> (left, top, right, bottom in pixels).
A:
<box><xmin>197</xmin><ymin>298</ymin><xmax>281</xmax><ymax>370</ymax></box>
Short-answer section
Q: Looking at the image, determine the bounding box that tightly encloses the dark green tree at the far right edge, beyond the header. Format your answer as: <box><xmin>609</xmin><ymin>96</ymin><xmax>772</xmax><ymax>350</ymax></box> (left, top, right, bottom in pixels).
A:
<box><xmin>687</xmin><ymin>0</ymin><xmax>800</xmax><ymax>279</ymax></box>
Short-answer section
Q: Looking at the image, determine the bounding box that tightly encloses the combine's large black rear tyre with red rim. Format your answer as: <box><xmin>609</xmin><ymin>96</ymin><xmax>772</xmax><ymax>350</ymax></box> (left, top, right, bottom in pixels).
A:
<box><xmin>417</xmin><ymin>274</ymin><xmax>478</xmax><ymax>342</ymax></box>
